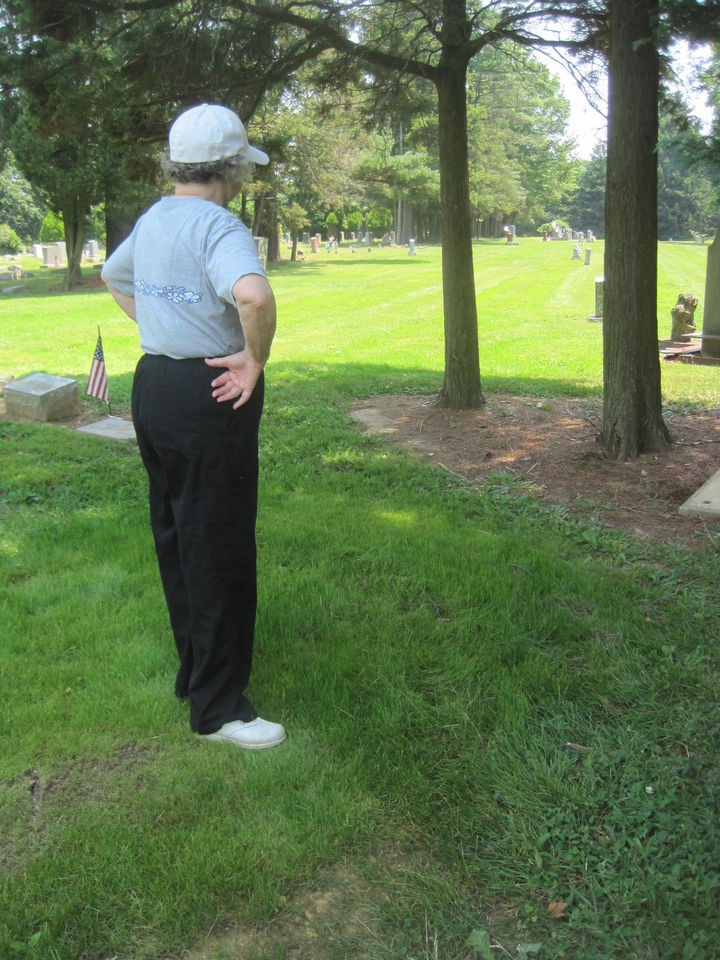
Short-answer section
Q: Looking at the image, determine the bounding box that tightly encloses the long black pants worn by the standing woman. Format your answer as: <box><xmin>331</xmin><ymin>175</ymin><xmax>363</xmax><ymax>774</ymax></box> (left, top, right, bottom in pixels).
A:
<box><xmin>132</xmin><ymin>354</ymin><xmax>264</xmax><ymax>733</ymax></box>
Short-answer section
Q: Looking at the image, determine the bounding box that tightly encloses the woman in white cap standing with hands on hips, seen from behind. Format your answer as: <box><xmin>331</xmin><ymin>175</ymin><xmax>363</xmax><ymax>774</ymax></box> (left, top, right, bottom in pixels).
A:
<box><xmin>102</xmin><ymin>104</ymin><xmax>285</xmax><ymax>750</ymax></box>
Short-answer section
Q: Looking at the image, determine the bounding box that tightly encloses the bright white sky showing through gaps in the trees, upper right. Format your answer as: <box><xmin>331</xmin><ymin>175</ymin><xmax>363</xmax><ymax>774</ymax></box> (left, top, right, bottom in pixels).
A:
<box><xmin>541</xmin><ymin>41</ymin><xmax>713</xmax><ymax>160</ymax></box>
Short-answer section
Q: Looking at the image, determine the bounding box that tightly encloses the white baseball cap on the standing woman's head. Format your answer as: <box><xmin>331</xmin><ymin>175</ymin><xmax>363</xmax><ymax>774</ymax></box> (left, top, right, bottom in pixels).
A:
<box><xmin>170</xmin><ymin>103</ymin><xmax>270</xmax><ymax>165</ymax></box>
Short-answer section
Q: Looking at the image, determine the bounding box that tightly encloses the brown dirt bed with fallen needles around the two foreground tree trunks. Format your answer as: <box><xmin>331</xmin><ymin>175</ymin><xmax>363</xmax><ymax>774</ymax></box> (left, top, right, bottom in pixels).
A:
<box><xmin>352</xmin><ymin>395</ymin><xmax>720</xmax><ymax>547</ymax></box>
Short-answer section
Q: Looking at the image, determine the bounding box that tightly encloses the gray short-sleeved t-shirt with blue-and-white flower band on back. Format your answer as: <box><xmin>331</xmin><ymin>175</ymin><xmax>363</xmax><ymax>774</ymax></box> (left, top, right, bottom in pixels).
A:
<box><xmin>102</xmin><ymin>197</ymin><xmax>265</xmax><ymax>360</ymax></box>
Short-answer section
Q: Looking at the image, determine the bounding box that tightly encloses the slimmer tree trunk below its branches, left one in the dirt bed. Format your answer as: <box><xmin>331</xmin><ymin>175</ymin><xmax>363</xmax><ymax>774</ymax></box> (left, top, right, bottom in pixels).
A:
<box><xmin>437</xmin><ymin>57</ymin><xmax>485</xmax><ymax>410</ymax></box>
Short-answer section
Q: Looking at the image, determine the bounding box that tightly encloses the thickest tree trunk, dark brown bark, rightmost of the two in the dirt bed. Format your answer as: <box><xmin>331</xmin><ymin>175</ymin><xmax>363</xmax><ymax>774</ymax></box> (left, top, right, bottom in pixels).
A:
<box><xmin>600</xmin><ymin>0</ymin><xmax>669</xmax><ymax>460</ymax></box>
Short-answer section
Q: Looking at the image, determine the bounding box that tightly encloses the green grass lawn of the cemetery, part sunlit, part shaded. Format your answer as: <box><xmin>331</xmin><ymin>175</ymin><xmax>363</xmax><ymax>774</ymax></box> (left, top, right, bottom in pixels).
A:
<box><xmin>0</xmin><ymin>240</ymin><xmax>720</xmax><ymax>960</ymax></box>
